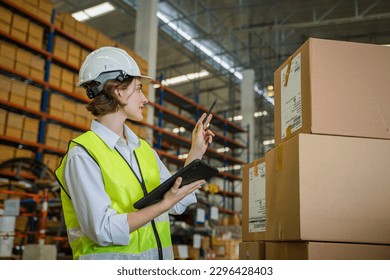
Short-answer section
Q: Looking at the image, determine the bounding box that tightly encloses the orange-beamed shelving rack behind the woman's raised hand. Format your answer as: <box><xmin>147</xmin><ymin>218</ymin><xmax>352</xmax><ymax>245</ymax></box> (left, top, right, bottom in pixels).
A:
<box><xmin>152</xmin><ymin>81</ymin><xmax>247</xmax><ymax>217</ymax></box>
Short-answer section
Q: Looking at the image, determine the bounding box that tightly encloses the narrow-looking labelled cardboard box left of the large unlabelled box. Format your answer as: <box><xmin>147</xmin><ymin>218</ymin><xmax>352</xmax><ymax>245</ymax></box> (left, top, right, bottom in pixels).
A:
<box><xmin>242</xmin><ymin>158</ymin><xmax>266</xmax><ymax>241</ymax></box>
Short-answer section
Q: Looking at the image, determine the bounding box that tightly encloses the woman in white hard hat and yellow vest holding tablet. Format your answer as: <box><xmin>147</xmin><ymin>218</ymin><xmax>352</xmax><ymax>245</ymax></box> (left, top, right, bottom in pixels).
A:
<box><xmin>56</xmin><ymin>47</ymin><xmax>214</xmax><ymax>259</ymax></box>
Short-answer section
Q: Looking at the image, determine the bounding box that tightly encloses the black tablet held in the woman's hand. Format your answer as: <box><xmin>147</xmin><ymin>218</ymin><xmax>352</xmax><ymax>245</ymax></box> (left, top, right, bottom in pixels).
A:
<box><xmin>133</xmin><ymin>159</ymin><xmax>219</xmax><ymax>209</ymax></box>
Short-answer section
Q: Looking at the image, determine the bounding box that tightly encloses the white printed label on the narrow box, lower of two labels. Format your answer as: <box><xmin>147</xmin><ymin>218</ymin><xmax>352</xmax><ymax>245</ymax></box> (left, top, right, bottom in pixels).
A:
<box><xmin>249</xmin><ymin>162</ymin><xmax>266</xmax><ymax>232</ymax></box>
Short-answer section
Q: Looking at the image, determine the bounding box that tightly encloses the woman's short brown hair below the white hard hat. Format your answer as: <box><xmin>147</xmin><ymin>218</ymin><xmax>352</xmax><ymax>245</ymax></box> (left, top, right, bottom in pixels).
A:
<box><xmin>86</xmin><ymin>77</ymin><xmax>133</xmax><ymax>117</ymax></box>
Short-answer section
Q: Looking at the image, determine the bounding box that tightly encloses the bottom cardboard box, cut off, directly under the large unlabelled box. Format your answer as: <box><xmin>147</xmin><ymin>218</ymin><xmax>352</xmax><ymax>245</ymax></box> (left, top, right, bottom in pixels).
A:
<box><xmin>265</xmin><ymin>242</ymin><xmax>390</xmax><ymax>260</ymax></box>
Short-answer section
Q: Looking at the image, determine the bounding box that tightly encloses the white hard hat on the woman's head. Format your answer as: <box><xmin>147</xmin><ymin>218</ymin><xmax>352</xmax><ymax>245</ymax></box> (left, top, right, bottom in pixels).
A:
<box><xmin>77</xmin><ymin>47</ymin><xmax>152</xmax><ymax>87</ymax></box>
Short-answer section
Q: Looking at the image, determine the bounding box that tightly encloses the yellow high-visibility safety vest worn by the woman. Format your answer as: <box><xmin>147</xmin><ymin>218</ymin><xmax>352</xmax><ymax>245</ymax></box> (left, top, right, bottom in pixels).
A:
<box><xmin>55</xmin><ymin>131</ymin><xmax>173</xmax><ymax>259</ymax></box>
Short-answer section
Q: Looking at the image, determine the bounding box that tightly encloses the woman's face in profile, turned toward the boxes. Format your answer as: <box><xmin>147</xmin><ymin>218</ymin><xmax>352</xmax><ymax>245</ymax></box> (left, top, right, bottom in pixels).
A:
<box><xmin>119</xmin><ymin>78</ymin><xmax>148</xmax><ymax>121</ymax></box>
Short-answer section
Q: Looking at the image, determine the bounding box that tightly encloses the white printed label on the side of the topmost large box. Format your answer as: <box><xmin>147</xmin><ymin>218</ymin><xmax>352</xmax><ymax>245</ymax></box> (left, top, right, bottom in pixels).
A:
<box><xmin>280</xmin><ymin>53</ymin><xmax>302</xmax><ymax>139</ymax></box>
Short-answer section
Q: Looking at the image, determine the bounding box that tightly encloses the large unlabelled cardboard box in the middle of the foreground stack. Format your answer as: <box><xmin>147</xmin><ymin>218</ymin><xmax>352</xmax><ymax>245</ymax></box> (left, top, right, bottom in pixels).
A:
<box><xmin>265</xmin><ymin>133</ymin><xmax>390</xmax><ymax>244</ymax></box>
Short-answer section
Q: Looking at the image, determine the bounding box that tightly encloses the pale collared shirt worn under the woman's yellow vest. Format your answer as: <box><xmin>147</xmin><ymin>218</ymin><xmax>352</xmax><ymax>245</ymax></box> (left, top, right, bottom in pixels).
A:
<box><xmin>64</xmin><ymin>120</ymin><xmax>196</xmax><ymax>246</ymax></box>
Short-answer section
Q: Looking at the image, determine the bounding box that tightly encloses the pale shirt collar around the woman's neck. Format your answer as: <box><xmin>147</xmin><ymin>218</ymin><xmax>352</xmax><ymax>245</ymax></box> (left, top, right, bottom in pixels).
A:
<box><xmin>91</xmin><ymin>120</ymin><xmax>140</xmax><ymax>149</ymax></box>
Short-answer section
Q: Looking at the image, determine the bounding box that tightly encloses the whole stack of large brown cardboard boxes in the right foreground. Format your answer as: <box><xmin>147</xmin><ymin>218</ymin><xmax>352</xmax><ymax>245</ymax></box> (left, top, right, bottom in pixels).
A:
<box><xmin>243</xmin><ymin>39</ymin><xmax>390</xmax><ymax>259</ymax></box>
